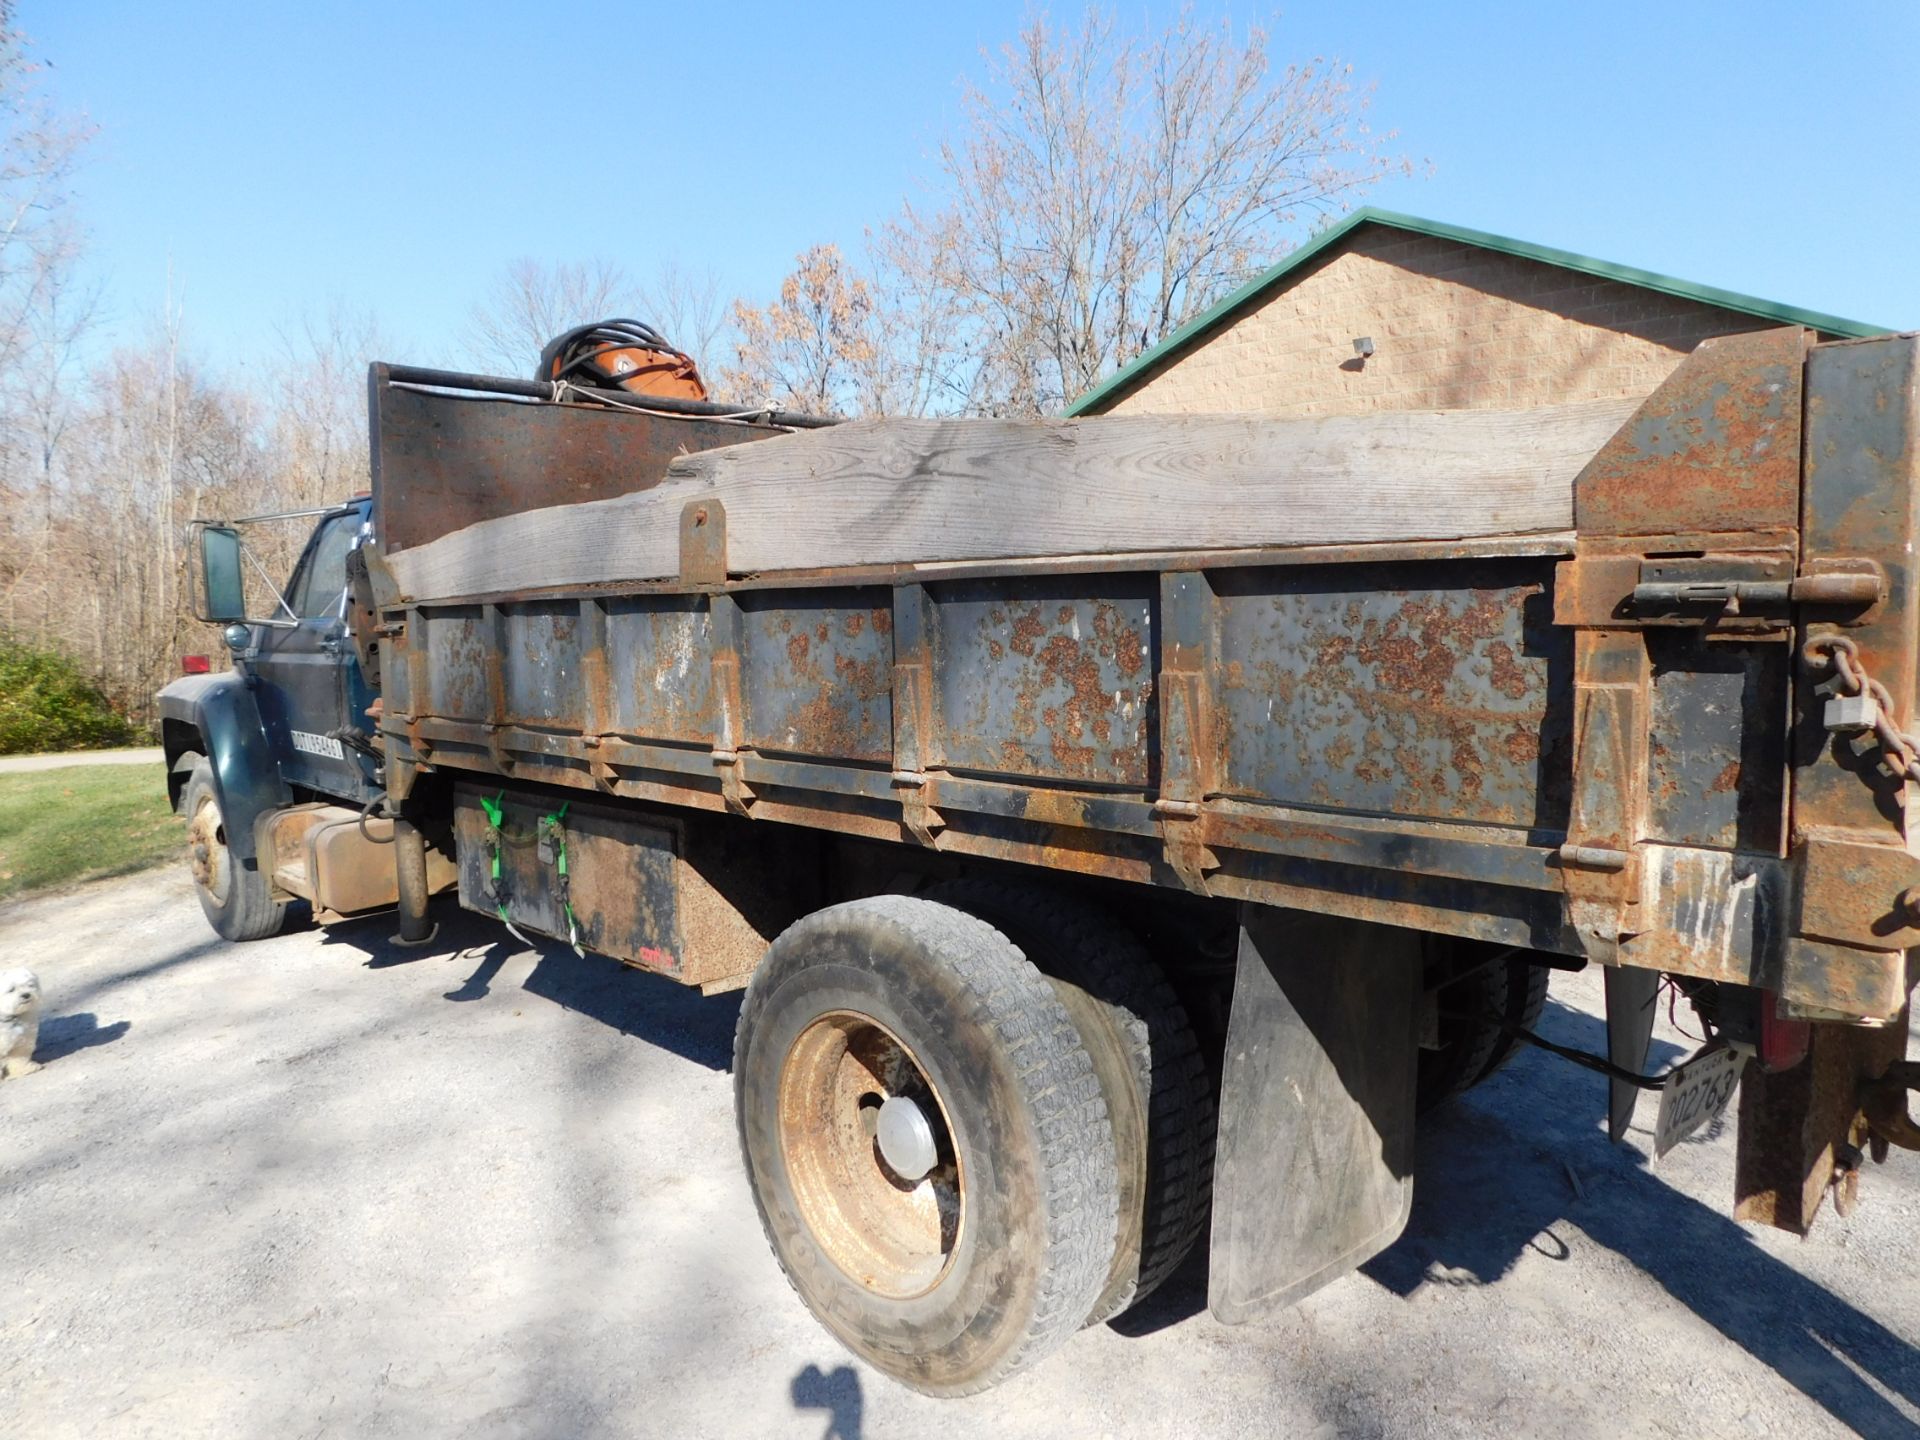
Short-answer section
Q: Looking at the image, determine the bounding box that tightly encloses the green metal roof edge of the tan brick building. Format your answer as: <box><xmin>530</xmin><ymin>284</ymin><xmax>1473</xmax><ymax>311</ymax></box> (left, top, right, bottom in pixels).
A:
<box><xmin>1066</xmin><ymin>205</ymin><xmax>1887</xmax><ymax>415</ymax></box>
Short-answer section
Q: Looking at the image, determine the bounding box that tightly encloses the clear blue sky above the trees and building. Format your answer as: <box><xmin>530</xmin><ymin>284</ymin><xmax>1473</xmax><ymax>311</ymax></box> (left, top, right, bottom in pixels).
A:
<box><xmin>33</xmin><ymin>0</ymin><xmax>1920</xmax><ymax>372</ymax></box>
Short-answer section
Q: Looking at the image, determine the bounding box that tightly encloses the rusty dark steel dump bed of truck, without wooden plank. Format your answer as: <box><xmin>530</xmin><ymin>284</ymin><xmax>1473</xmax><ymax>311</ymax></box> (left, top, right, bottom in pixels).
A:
<box><xmin>374</xmin><ymin>330</ymin><xmax>1920</xmax><ymax>1052</ymax></box>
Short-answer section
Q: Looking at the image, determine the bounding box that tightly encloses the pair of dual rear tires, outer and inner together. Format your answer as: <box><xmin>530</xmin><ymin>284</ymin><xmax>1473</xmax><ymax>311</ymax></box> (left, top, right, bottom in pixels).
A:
<box><xmin>733</xmin><ymin>881</ymin><xmax>1213</xmax><ymax>1396</ymax></box>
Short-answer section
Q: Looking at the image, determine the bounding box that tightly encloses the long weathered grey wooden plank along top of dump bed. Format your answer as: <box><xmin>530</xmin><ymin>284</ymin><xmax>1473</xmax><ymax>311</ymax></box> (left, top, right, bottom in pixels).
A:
<box><xmin>388</xmin><ymin>401</ymin><xmax>1636</xmax><ymax>599</ymax></box>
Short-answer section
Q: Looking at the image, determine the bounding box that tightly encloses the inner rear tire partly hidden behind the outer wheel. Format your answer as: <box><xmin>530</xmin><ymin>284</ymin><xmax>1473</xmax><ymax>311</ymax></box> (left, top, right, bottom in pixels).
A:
<box><xmin>927</xmin><ymin>877</ymin><xmax>1215</xmax><ymax>1325</ymax></box>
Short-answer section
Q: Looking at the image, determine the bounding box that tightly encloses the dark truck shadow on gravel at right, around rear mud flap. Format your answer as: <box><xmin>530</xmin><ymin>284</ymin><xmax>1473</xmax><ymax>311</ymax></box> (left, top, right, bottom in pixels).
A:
<box><xmin>1114</xmin><ymin>1000</ymin><xmax>1920</xmax><ymax>1436</ymax></box>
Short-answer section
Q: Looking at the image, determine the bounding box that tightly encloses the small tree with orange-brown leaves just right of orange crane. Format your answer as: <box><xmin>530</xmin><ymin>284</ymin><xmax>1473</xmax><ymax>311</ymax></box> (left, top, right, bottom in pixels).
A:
<box><xmin>724</xmin><ymin>246</ymin><xmax>877</xmax><ymax>415</ymax></box>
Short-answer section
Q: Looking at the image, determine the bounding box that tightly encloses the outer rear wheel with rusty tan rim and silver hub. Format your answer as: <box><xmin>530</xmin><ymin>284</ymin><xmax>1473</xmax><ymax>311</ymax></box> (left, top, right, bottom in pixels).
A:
<box><xmin>733</xmin><ymin>895</ymin><xmax>1117</xmax><ymax>1394</ymax></box>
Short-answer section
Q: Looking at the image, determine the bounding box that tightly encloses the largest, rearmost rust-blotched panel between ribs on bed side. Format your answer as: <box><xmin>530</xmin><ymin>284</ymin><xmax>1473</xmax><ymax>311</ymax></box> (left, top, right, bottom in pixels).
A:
<box><xmin>1213</xmin><ymin>559</ymin><xmax>1571</xmax><ymax>829</ymax></box>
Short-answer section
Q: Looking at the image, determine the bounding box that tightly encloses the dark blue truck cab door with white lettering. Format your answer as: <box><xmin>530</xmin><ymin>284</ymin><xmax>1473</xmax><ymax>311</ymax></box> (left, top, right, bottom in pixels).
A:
<box><xmin>253</xmin><ymin>507</ymin><xmax>374</xmax><ymax>803</ymax></box>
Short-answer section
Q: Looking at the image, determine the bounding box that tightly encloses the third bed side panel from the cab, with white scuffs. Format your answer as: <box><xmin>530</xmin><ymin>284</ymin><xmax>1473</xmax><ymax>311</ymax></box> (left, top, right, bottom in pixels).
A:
<box><xmin>603</xmin><ymin>595</ymin><xmax>714</xmax><ymax>745</ymax></box>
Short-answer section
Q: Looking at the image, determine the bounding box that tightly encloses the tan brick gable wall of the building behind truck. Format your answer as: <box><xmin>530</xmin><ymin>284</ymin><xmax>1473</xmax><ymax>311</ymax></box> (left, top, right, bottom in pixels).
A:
<box><xmin>1100</xmin><ymin>225</ymin><xmax>1768</xmax><ymax>415</ymax></box>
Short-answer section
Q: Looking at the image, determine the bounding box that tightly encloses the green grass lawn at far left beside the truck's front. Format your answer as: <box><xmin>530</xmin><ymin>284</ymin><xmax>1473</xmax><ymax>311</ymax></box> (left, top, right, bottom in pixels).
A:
<box><xmin>0</xmin><ymin>764</ymin><xmax>186</xmax><ymax>900</ymax></box>
